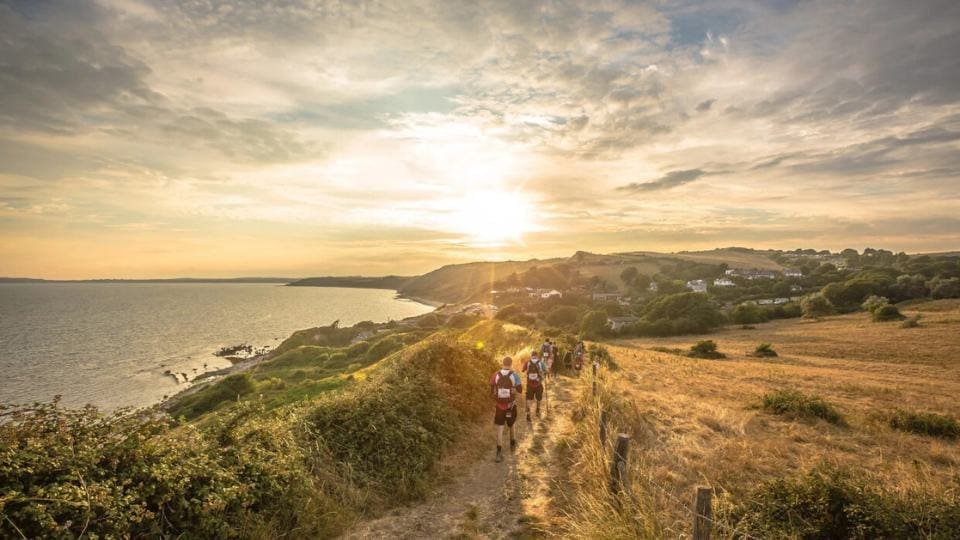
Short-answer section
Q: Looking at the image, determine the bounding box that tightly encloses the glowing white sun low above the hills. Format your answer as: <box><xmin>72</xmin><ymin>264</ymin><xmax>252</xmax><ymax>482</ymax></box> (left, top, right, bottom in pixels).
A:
<box><xmin>450</xmin><ymin>191</ymin><xmax>536</xmax><ymax>247</ymax></box>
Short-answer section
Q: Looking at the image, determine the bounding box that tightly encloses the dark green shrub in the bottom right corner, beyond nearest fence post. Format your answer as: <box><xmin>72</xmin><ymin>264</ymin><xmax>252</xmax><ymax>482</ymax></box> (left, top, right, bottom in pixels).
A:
<box><xmin>718</xmin><ymin>466</ymin><xmax>960</xmax><ymax>540</ymax></box>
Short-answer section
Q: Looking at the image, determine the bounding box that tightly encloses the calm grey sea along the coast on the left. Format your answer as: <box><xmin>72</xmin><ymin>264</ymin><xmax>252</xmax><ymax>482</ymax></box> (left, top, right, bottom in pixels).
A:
<box><xmin>0</xmin><ymin>283</ymin><xmax>432</xmax><ymax>409</ymax></box>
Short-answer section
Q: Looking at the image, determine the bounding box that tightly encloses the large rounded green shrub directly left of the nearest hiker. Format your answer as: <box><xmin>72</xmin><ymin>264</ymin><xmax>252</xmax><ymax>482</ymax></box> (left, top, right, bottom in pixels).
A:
<box><xmin>309</xmin><ymin>340</ymin><xmax>496</xmax><ymax>500</ymax></box>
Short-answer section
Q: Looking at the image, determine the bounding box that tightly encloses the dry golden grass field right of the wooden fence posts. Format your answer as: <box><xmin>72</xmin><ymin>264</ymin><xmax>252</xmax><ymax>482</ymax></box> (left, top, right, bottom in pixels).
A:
<box><xmin>610</xmin><ymin>301</ymin><xmax>960</xmax><ymax>536</ymax></box>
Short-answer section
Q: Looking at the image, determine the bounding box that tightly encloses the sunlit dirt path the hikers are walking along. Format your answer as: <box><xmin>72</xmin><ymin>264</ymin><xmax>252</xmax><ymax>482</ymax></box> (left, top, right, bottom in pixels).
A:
<box><xmin>343</xmin><ymin>378</ymin><xmax>572</xmax><ymax>539</ymax></box>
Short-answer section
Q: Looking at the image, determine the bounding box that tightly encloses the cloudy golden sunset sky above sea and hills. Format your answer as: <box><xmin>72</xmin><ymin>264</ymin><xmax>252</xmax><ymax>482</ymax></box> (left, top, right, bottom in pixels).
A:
<box><xmin>0</xmin><ymin>0</ymin><xmax>960</xmax><ymax>278</ymax></box>
